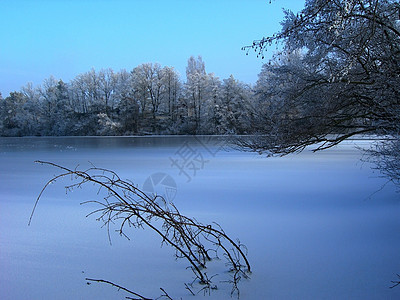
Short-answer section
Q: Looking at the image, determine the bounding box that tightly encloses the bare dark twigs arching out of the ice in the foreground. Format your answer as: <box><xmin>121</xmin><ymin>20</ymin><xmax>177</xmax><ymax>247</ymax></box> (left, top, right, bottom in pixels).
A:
<box><xmin>29</xmin><ymin>161</ymin><xmax>251</xmax><ymax>299</ymax></box>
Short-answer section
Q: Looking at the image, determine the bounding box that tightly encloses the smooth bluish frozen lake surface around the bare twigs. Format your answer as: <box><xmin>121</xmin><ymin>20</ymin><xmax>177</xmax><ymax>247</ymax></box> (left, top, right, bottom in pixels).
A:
<box><xmin>0</xmin><ymin>137</ymin><xmax>400</xmax><ymax>300</ymax></box>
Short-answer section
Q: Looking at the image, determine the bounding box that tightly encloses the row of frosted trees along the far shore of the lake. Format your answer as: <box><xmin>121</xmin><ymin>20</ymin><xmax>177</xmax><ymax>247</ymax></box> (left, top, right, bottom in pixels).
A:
<box><xmin>0</xmin><ymin>56</ymin><xmax>254</xmax><ymax>136</ymax></box>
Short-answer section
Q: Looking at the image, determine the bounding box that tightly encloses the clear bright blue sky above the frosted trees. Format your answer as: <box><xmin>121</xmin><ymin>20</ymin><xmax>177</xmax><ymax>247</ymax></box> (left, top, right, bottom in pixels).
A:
<box><xmin>0</xmin><ymin>0</ymin><xmax>304</xmax><ymax>97</ymax></box>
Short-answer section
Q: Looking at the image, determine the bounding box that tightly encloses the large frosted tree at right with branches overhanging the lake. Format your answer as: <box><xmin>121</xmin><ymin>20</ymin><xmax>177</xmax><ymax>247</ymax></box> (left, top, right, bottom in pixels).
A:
<box><xmin>241</xmin><ymin>0</ymin><xmax>400</xmax><ymax>154</ymax></box>
